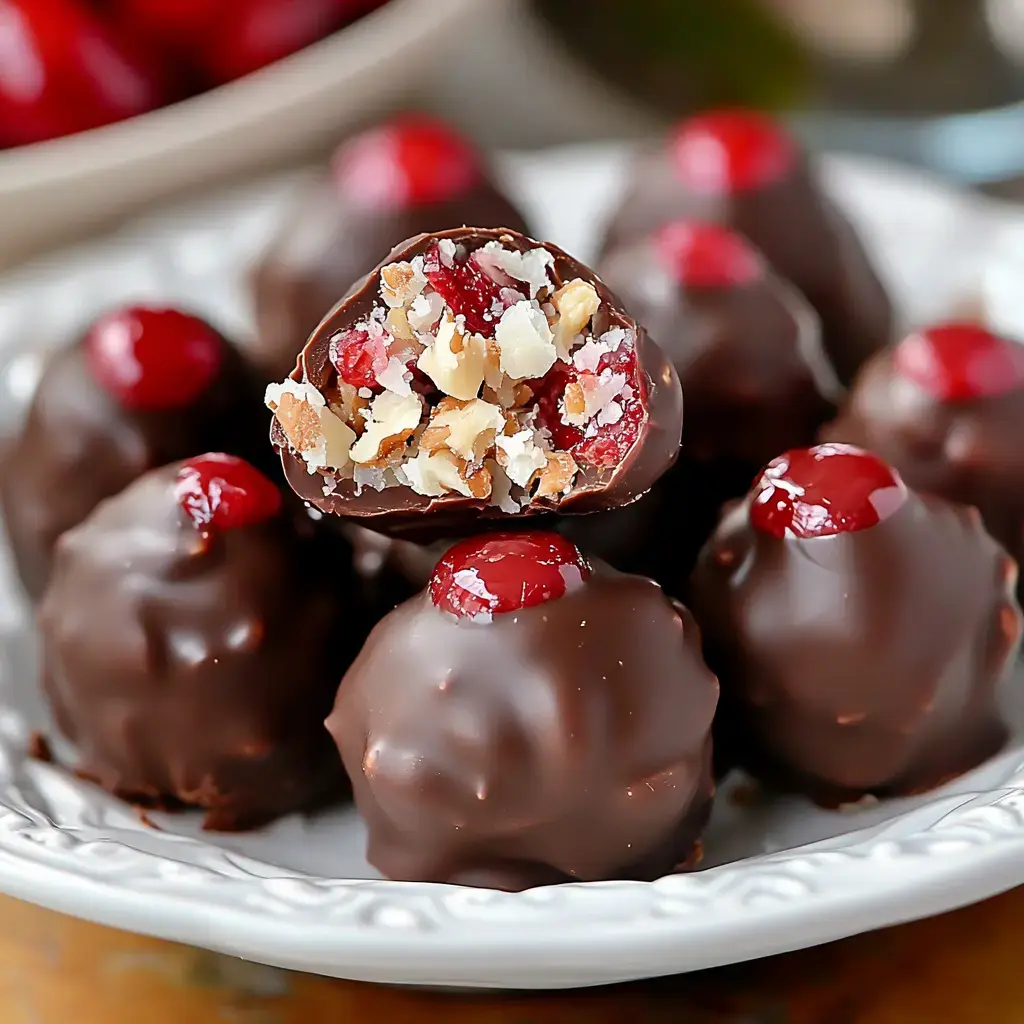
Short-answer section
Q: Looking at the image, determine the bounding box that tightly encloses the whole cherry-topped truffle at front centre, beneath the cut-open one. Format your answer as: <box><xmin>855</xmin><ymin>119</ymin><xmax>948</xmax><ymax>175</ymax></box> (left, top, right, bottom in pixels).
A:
<box><xmin>327</xmin><ymin>531</ymin><xmax>718</xmax><ymax>890</ymax></box>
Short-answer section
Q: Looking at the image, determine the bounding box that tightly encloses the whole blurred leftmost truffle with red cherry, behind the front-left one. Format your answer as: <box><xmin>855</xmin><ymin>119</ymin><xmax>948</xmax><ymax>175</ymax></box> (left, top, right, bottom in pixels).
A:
<box><xmin>0</xmin><ymin>306</ymin><xmax>270</xmax><ymax>599</ymax></box>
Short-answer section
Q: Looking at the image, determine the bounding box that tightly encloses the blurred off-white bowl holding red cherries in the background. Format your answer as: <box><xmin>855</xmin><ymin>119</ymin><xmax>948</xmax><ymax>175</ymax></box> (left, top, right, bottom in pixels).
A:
<box><xmin>0</xmin><ymin>0</ymin><xmax>487</xmax><ymax>265</ymax></box>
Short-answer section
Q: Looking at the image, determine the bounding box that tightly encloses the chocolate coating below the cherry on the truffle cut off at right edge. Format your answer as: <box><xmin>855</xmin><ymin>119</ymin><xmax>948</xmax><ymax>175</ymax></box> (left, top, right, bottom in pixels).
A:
<box><xmin>821</xmin><ymin>349</ymin><xmax>1024</xmax><ymax>598</ymax></box>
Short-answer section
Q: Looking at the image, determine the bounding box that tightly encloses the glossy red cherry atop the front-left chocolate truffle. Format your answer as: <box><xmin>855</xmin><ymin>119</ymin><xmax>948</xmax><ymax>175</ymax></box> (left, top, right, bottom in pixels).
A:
<box><xmin>174</xmin><ymin>452</ymin><xmax>281</xmax><ymax>530</ymax></box>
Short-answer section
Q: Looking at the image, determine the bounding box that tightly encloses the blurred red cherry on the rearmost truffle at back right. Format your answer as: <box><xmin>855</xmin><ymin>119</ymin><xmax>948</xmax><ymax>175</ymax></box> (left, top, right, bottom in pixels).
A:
<box><xmin>672</xmin><ymin>111</ymin><xmax>799</xmax><ymax>196</ymax></box>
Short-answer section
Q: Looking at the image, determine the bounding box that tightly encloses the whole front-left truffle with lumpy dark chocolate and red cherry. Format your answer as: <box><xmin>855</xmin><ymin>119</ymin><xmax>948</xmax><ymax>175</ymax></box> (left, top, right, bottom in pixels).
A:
<box><xmin>39</xmin><ymin>454</ymin><xmax>365</xmax><ymax>830</ymax></box>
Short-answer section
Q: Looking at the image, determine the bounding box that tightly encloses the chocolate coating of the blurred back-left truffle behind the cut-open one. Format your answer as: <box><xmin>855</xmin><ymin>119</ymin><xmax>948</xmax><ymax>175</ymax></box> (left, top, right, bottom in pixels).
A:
<box><xmin>248</xmin><ymin>177</ymin><xmax>528</xmax><ymax>380</ymax></box>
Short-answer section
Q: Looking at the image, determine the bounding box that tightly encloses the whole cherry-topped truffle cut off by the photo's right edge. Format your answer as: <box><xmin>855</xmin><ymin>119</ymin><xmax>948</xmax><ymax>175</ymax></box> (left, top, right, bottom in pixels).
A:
<box><xmin>822</xmin><ymin>324</ymin><xmax>1024</xmax><ymax>589</ymax></box>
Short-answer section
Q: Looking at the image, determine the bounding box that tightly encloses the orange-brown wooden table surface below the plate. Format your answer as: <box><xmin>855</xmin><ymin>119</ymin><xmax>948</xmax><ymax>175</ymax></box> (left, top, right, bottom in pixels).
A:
<box><xmin>0</xmin><ymin>888</ymin><xmax>1024</xmax><ymax>1024</ymax></box>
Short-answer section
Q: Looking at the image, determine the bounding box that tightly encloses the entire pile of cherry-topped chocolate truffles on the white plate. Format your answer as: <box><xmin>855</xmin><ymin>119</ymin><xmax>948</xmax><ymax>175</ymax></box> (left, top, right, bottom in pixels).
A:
<box><xmin>0</xmin><ymin>105</ymin><xmax>1024</xmax><ymax>890</ymax></box>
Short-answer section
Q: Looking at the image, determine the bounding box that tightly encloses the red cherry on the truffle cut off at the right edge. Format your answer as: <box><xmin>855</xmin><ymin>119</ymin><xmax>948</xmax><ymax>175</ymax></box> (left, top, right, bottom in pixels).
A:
<box><xmin>893</xmin><ymin>324</ymin><xmax>1024</xmax><ymax>401</ymax></box>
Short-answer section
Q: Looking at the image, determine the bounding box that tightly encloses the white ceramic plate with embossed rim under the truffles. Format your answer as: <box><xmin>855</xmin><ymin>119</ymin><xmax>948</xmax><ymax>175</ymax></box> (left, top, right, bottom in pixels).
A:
<box><xmin>0</xmin><ymin>148</ymin><xmax>1024</xmax><ymax>988</ymax></box>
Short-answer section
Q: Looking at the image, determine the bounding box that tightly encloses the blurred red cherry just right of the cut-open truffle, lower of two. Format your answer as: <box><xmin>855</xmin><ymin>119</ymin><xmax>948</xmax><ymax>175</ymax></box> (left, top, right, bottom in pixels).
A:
<box><xmin>654</xmin><ymin>220</ymin><xmax>764</xmax><ymax>288</ymax></box>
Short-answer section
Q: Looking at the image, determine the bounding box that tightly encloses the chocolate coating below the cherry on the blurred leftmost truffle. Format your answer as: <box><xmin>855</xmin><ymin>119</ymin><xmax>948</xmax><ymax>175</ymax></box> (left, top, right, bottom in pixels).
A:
<box><xmin>0</xmin><ymin>331</ymin><xmax>269</xmax><ymax>600</ymax></box>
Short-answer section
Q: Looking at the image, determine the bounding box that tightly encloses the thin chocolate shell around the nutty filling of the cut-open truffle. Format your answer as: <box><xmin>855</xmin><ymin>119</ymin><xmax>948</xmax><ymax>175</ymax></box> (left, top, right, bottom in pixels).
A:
<box><xmin>270</xmin><ymin>227</ymin><xmax>683</xmax><ymax>541</ymax></box>
